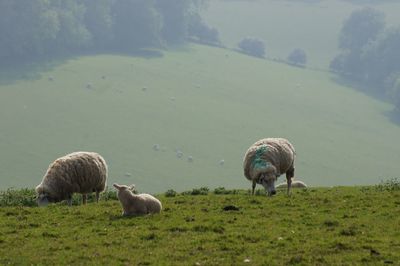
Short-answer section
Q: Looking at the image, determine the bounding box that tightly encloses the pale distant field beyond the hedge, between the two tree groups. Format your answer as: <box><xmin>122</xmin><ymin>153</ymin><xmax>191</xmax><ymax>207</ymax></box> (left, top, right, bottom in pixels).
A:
<box><xmin>204</xmin><ymin>0</ymin><xmax>400</xmax><ymax>69</ymax></box>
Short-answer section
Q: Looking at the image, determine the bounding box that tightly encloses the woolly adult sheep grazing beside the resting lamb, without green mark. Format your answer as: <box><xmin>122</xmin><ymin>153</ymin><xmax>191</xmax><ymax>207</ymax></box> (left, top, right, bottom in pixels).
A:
<box><xmin>35</xmin><ymin>151</ymin><xmax>108</xmax><ymax>206</ymax></box>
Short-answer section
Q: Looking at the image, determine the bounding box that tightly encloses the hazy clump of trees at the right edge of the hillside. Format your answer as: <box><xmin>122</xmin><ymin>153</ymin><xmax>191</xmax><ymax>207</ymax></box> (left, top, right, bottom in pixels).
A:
<box><xmin>330</xmin><ymin>8</ymin><xmax>400</xmax><ymax>112</ymax></box>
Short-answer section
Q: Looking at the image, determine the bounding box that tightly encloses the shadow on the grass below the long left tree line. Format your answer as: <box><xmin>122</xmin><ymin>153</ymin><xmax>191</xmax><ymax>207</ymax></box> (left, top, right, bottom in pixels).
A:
<box><xmin>0</xmin><ymin>49</ymin><xmax>163</xmax><ymax>86</ymax></box>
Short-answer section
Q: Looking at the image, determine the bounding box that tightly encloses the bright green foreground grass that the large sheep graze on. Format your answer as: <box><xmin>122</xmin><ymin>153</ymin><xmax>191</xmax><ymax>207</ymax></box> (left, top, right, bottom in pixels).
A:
<box><xmin>0</xmin><ymin>184</ymin><xmax>400</xmax><ymax>265</ymax></box>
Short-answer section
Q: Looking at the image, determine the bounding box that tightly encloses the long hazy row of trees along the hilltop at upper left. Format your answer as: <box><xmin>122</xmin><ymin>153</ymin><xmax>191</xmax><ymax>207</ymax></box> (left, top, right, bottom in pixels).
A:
<box><xmin>0</xmin><ymin>0</ymin><xmax>218</xmax><ymax>64</ymax></box>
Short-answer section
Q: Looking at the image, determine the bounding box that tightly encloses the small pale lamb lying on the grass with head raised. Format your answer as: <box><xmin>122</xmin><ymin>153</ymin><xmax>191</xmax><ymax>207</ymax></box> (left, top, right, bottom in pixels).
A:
<box><xmin>113</xmin><ymin>183</ymin><xmax>162</xmax><ymax>216</ymax></box>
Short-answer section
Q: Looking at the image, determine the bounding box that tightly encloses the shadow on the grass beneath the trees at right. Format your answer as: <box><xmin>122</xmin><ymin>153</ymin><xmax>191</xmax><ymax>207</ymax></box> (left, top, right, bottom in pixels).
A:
<box><xmin>332</xmin><ymin>76</ymin><xmax>400</xmax><ymax>126</ymax></box>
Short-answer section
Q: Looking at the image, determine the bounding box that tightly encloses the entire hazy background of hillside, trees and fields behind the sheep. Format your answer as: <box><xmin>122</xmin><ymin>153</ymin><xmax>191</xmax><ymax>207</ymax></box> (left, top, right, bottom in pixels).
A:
<box><xmin>0</xmin><ymin>0</ymin><xmax>400</xmax><ymax>192</ymax></box>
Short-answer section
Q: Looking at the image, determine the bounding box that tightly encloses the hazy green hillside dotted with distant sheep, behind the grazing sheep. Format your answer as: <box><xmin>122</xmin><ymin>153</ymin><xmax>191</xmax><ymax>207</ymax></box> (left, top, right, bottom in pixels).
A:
<box><xmin>0</xmin><ymin>45</ymin><xmax>400</xmax><ymax>192</ymax></box>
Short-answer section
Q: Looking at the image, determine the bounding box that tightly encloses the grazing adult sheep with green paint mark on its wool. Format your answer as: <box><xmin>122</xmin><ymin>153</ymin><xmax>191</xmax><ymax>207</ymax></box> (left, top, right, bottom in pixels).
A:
<box><xmin>243</xmin><ymin>138</ymin><xmax>296</xmax><ymax>196</ymax></box>
